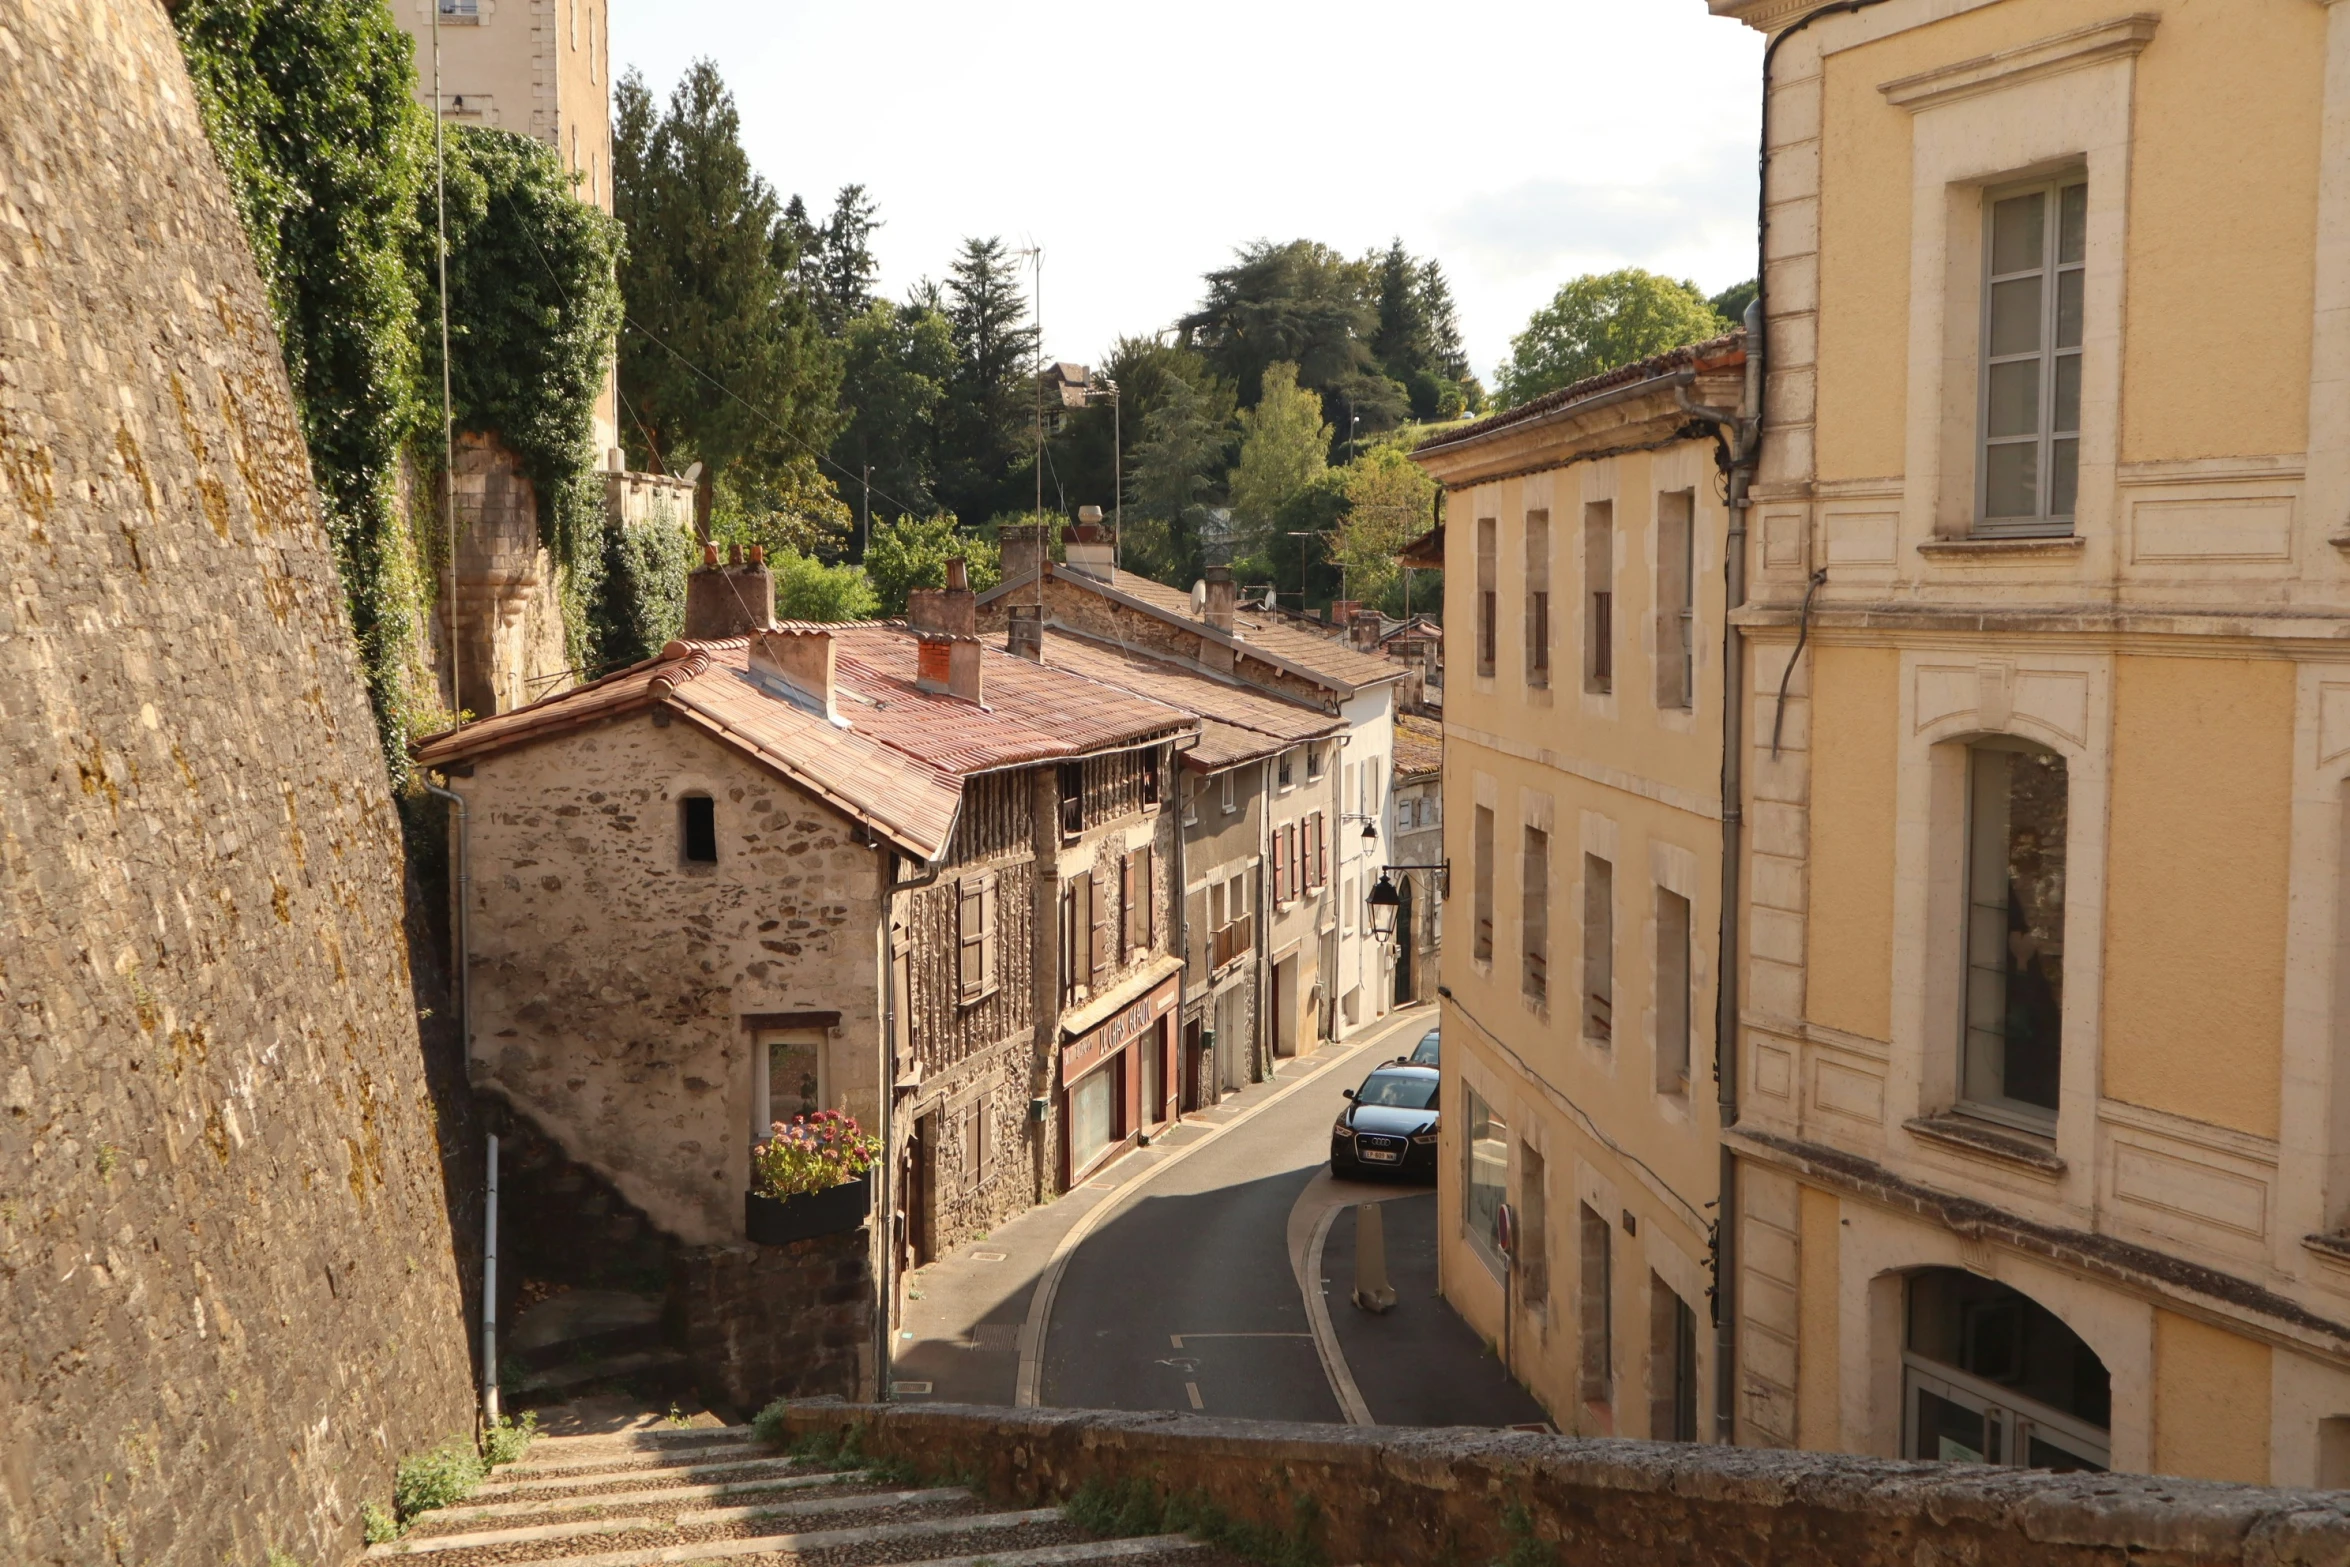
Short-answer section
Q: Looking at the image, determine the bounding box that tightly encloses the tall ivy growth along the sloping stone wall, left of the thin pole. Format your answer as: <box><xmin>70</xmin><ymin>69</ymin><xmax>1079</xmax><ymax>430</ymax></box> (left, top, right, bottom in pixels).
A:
<box><xmin>172</xmin><ymin>0</ymin><xmax>432</xmax><ymax>782</ymax></box>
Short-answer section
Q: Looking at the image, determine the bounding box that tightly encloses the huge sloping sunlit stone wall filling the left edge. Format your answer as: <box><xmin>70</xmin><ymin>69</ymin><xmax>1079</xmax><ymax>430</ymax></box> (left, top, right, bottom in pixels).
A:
<box><xmin>0</xmin><ymin>0</ymin><xmax>472</xmax><ymax>1565</ymax></box>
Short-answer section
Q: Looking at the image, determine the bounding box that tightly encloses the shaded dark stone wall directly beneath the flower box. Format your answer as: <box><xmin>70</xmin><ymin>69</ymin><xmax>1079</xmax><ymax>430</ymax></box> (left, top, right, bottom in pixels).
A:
<box><xmin>672</xmin><ymin>1229</ymin><xmax>874</xmax><ymax>1419</ymax></box>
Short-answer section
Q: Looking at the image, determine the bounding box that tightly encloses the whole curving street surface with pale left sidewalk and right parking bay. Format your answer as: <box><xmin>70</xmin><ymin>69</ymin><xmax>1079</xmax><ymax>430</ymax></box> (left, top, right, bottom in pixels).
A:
<box><xmin>891</xmin><ymin>1008</ymin><xmax>1544</xmax><ymax>1426</ymax></box>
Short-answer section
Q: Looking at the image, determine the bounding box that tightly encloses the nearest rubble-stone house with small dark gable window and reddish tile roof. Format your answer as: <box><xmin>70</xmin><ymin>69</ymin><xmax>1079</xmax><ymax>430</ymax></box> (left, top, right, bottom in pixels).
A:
<box><xmin>416</xmin><ymin>564</ymin><xmax>1196</xmax><ymax>1400</ymax></box>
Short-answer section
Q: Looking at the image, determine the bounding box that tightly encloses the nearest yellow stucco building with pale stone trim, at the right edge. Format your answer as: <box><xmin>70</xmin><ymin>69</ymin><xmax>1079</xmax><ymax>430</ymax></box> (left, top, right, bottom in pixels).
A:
<box><xmin>1710</xmin><ymin>0</ymin><xmax>2350</xmax><ymax>1485</ymax></box>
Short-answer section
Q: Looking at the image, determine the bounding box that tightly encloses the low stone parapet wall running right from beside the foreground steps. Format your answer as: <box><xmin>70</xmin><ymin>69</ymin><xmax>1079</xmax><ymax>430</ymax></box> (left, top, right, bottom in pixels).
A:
<box><xmin>790</xmin><ymin>1403</ymin><xmax>2350</xmax><ymax>1567</ymax></box>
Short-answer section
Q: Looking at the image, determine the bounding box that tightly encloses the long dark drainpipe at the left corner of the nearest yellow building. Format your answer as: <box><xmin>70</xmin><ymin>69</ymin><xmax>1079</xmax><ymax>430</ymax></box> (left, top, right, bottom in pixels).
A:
<box><xmin>1713</xmin><ymin>0</ymin><xmax>1885</xmax><ymax>1442</ymax></box>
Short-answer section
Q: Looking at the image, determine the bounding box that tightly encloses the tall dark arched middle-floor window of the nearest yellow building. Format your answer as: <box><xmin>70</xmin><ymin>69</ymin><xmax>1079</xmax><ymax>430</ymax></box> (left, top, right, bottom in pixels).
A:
<box><xmin>1960</xmin><ymin>742</ymin><xmax>2066</xmax><ymax>1132</ymax></box>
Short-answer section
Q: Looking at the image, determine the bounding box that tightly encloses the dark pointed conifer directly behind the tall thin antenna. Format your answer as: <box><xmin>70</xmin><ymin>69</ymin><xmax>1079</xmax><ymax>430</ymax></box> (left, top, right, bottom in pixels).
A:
<box><xmin>938</xmin><ymin>240</ymin><xmax>1039</xmax><ymax>517</ymax></box>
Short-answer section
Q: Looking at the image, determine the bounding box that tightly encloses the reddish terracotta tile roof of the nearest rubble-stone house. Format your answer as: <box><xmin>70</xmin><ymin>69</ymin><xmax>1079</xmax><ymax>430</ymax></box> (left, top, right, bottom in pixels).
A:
<box><xmin>411</xmin><ymin>620</ymin><xmax>1196</xmax><ymax>860</ymax></box>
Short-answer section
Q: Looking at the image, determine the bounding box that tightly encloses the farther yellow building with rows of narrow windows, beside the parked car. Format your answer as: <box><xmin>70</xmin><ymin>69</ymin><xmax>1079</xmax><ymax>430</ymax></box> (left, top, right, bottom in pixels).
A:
<box><xmin>1415</xmin><ymin>336</ymin><xmax>1746</xmax><ymax>1440</ymax></box>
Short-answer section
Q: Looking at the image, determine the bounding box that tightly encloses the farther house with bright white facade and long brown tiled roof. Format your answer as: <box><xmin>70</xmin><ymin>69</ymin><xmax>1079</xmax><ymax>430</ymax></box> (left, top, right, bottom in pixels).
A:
<box><xmin>980</xmin><ymin>526</ymin><xmax>1405</xmax><ymax>1057</ymax></box>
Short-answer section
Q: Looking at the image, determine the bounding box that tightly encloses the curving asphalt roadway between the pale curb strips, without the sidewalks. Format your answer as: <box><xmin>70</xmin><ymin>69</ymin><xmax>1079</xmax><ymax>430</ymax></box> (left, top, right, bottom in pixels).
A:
<box><xmin>1041</xmin><ymin>1029</ymin><xmax>1417</xmax><ymax>1421</ymax></box>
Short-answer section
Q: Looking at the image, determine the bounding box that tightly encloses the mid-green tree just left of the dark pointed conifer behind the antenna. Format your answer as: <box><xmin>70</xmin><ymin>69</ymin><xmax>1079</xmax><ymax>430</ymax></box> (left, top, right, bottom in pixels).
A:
<box><xmin>832</xmin><ymin>298</ymin><xmax>956</xmax><ymax>535</ymax></box>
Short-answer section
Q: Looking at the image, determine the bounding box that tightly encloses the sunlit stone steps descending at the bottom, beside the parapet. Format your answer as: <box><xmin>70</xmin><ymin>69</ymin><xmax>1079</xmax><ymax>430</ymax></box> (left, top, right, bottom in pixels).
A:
<box><xmin>367</xmin><ymin>1426</ymin><xmax>1238</xmax><ymax>1567</ymax></box>
